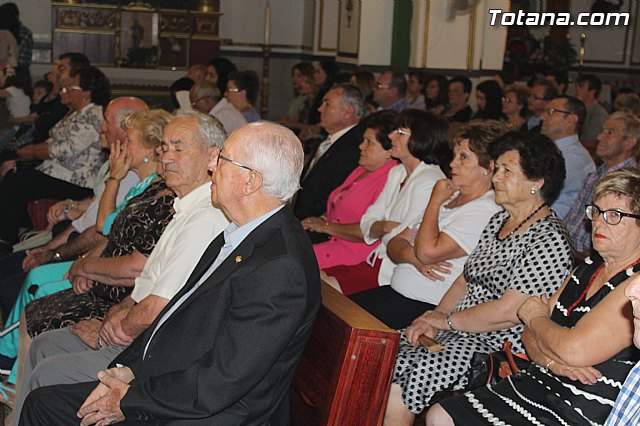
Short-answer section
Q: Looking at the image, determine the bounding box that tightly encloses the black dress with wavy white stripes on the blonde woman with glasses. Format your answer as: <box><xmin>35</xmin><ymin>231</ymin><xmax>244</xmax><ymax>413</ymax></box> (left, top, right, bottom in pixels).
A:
<box><xmin>440</xmin><ymin>253</ymin><xmax>640</xmax><ymax>426</ymax></box>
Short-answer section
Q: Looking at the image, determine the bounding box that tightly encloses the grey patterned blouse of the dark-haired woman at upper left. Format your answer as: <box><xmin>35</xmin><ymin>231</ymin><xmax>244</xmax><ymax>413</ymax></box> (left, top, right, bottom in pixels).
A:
<box><xmin>37</xmin><ymin>104</ymin><xmax>105</xmax><ymax>188</ymax></box>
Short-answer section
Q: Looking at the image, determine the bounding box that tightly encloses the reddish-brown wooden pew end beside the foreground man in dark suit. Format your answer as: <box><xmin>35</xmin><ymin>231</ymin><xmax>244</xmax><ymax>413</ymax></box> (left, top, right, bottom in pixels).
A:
<box><xmin>291</xmin><ymin>282</ymin><xmax>400</xmax><ymax>426</ymax></box>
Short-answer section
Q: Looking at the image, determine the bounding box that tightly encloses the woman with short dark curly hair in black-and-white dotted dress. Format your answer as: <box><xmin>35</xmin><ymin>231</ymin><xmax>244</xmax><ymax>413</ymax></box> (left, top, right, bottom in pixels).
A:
<box><xmin>385</xmin><ymin>132</ymin><xmax>572</xmax><ymax>425</ymax></box>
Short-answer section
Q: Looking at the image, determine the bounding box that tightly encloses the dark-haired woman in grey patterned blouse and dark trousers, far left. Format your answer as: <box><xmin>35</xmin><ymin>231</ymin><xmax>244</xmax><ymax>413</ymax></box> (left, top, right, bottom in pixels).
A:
<box><xmin>0</xmin><ymin>67</ymin><xmax>110</xmax><ymax>254</ymax></box>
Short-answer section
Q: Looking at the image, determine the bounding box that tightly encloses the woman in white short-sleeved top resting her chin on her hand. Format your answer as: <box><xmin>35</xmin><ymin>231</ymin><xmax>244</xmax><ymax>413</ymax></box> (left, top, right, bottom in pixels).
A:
<box><xmin>351</xmin><ymin>121</ymin><xmax>504</xmax><ymax>329</ymax></box>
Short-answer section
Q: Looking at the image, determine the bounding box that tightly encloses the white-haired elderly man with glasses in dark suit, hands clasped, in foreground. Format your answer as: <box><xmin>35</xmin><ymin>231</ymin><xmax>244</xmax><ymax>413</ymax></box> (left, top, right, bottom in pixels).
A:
<box><xmin>20</xmin><ymin>122</ymin><xmax>320</xmax><ymax>425</ymax></box>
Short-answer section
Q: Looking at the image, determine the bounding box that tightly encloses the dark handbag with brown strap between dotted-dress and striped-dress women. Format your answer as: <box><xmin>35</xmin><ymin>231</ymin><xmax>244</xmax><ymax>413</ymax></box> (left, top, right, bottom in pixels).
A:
<box><xmin>466</xmin><ymin>340</ymin><xmax>531</xmax><ymax>390</ymax></box>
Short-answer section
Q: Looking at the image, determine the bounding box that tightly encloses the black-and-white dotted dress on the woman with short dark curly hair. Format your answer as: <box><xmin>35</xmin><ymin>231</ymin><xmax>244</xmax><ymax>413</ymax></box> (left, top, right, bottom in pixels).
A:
<box><xmin>393</xmin><ymin>211</ymin><xmax>572</xmax><ymax>414</ymax></box>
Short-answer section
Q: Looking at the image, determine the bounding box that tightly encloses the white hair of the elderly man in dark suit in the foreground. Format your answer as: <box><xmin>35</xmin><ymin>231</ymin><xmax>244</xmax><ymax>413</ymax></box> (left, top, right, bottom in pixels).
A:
<box><xmin>236</xmin><ymin>121</ymin><xmax>304</xmax><ymax>202</ymax></box>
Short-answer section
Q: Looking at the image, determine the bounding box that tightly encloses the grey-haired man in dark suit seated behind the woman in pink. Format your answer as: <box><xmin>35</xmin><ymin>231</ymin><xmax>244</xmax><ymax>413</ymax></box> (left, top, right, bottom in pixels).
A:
<box><xmin>293</xmin><ymin>83</ymin><xmax>365</xmax><ymax>243</ymax></box>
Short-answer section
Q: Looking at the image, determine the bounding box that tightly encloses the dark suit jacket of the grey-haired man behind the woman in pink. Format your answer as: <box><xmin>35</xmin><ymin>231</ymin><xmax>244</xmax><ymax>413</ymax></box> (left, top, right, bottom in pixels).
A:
<box><xmin>293</xmin><ymin>124</ymin><xmax>363</xmax><ymax>220</ymax></box>
